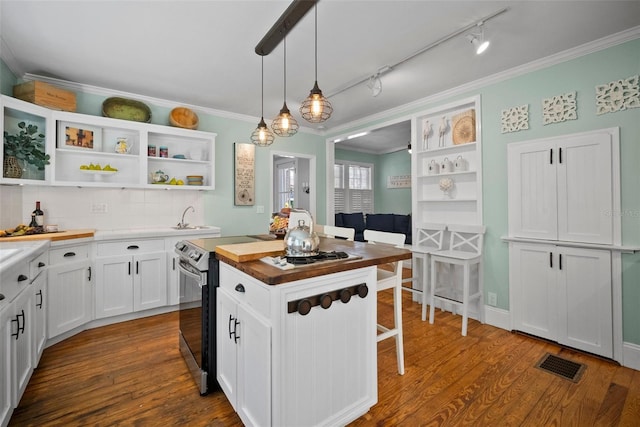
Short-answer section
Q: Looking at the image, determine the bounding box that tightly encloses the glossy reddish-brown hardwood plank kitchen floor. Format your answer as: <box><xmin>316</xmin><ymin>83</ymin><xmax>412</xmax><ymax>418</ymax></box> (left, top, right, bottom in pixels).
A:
<box><xmin>10</xmin><ymin>293</ymin><xmax>640</xmax><ymax>427</ymax></box>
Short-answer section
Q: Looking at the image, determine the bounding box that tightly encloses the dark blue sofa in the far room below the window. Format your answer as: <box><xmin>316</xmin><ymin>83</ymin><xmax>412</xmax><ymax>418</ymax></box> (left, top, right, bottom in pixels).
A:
<box><xmin>335</xmin><ymin>212</ymin><xmax>412</xmax><ymax>244</ymax></box>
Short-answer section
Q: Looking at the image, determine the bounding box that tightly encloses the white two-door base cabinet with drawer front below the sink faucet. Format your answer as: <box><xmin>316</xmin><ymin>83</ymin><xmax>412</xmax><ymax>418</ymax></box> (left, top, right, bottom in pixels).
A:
<box><xmin>95</xmin><ymin>239</ymin><xmax>167</xmax><ymax>319</ymax></box>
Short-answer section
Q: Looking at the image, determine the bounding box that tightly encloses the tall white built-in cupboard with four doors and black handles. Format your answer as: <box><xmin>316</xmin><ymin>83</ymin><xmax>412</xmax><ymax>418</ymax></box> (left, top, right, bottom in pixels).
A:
<box><xmin>505</xmin><ymin>128</ymin><xmax>625</xmax><ymax>359</ymax></box>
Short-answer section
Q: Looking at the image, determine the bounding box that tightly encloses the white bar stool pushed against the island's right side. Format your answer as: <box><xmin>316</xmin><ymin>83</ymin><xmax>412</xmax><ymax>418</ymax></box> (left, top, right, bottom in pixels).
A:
<box><xmin>364</xmin><ymin>230</ymin><xmax>406</xmax><ymax>375</ymax></box>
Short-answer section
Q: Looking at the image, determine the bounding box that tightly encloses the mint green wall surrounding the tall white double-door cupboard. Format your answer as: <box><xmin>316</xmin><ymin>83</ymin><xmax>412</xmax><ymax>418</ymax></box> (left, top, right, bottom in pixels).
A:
<box><xmin>329</xmin><ymin>40</ymin><xmax>640</xmax><ymax>345</ymax></box>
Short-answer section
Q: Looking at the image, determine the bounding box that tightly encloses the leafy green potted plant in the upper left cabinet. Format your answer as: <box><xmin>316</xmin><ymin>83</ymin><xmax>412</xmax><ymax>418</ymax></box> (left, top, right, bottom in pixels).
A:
<box><xmin>4</xmin><ymin>122</ymin><xmax>51</xmax><ymax>178</ymax></box>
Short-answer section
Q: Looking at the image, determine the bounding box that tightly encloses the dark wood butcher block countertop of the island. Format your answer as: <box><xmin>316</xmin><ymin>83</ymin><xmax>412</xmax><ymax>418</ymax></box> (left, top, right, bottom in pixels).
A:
<box><xmin>216</xmin><ymin>237</ymin><xmax>411</xmax><ymax>285</ymax></box>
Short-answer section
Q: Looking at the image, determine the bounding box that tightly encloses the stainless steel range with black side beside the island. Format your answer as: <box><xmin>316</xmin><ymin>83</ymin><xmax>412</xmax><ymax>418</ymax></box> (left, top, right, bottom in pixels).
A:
<box><xmin>175</xmin><ymin>236</ymin><xmax>260</xmax><ymax>395</ymax></box>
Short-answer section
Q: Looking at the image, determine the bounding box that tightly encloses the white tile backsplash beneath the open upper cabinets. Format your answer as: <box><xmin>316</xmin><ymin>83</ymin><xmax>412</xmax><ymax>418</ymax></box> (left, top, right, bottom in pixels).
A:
<box><xmin>6</xmin><ymin>186</ymin><xmax>206</xmax><ymax>230</ymax></box>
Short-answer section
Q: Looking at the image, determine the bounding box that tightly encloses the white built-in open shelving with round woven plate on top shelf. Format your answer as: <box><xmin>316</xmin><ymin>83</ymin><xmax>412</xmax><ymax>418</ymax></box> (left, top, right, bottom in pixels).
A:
<box><xmin>411</xmin><ymin>97</ymin><xmax>482</xmax><ymax>229</ymax></box>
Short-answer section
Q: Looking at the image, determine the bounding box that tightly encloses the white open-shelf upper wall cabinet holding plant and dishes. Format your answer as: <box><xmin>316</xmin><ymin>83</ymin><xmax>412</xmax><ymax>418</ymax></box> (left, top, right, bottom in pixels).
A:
<box><xmin>0</xmin><ymin>95</ymin><xmax>216</xmax><ymax>190</ymax></box>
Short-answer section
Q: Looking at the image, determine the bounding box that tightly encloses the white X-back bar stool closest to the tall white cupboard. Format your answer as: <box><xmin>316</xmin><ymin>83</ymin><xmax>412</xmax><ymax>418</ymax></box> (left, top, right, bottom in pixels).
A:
<box><xmin>429</xmin><ymin>225</ymin><xmax>486</xmax><ymax>336</ymax></box>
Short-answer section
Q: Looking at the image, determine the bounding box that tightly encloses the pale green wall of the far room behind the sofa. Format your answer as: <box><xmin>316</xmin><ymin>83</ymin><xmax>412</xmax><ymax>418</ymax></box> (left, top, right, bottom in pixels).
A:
<box><xmin>335</xmin><ymin>149</ymin><xmax>411</xmax><ymax>214</ymax></box>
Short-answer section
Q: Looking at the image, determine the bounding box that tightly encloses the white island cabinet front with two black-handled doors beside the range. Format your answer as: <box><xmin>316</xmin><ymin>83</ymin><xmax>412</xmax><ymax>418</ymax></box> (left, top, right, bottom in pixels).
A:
<box><xmin>216</xmin><ymin>273</ymin><xmax>271</xmax><ymax>426</ymax></box>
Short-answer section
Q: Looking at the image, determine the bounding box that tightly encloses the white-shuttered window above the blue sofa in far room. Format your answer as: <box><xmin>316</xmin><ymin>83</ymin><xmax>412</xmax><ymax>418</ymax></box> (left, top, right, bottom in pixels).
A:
<box><xmin>333</xmin><ymin>161</ymin><xmax>373</xmax><ymax>213</ymax></box>
